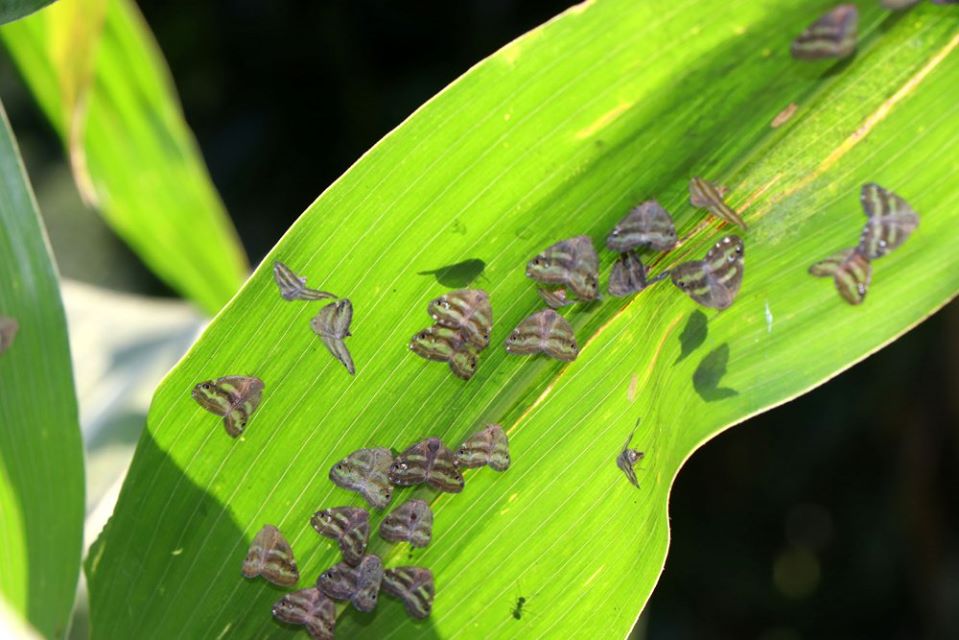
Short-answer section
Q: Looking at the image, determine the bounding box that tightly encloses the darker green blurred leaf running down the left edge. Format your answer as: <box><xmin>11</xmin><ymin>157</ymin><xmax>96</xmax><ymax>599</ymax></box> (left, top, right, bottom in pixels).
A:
<box><xmin>0</xmin><ymin>99</ymin><xmax>84</xmax><ymax>637</ymax></box>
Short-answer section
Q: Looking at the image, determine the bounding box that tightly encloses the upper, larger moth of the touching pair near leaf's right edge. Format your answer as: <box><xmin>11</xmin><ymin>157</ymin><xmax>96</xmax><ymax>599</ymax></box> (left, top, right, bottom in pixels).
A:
<box><xmin>858</xmin><ymin>182</ymin><xmax>919</xmax><ymax>260</ymax></box>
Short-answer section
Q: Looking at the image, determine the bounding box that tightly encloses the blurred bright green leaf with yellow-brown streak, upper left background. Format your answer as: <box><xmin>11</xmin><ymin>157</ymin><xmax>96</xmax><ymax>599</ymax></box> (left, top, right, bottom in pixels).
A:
<box><xmin>0</xmin><ymin>0</ymin><xmax>247</xmax><ymax>313</ymax></box>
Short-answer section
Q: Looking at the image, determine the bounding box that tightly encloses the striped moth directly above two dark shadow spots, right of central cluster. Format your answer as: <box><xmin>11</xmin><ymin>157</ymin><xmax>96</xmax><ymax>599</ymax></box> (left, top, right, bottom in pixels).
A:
<box><xmin>670</xmin><ymin>236</ymin><xmax>745</xmax><ymax>309</ymax></box>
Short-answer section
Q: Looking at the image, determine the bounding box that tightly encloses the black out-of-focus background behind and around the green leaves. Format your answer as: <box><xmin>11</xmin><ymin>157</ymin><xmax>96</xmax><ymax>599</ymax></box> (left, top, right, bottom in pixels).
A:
<box><xmin>0</xmin><ymin>0</ymin><xmax>959</xmax><ymax>640</ymax></box>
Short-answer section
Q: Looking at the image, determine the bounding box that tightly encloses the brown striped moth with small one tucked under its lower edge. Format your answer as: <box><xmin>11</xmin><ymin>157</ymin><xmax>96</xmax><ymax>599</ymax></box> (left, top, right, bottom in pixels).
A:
<box><xmin>526</xmin><ymin>236</ymin><xmax>599</xmax><ymax>302</ymax></box>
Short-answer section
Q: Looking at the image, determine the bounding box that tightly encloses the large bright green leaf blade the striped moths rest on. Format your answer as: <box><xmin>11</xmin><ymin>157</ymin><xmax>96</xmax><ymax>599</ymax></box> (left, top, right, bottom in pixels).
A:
<box><xmin>88</xmin><ymin>0</ymin><xmax>959</xmax><ymax>638</ymax></box>
